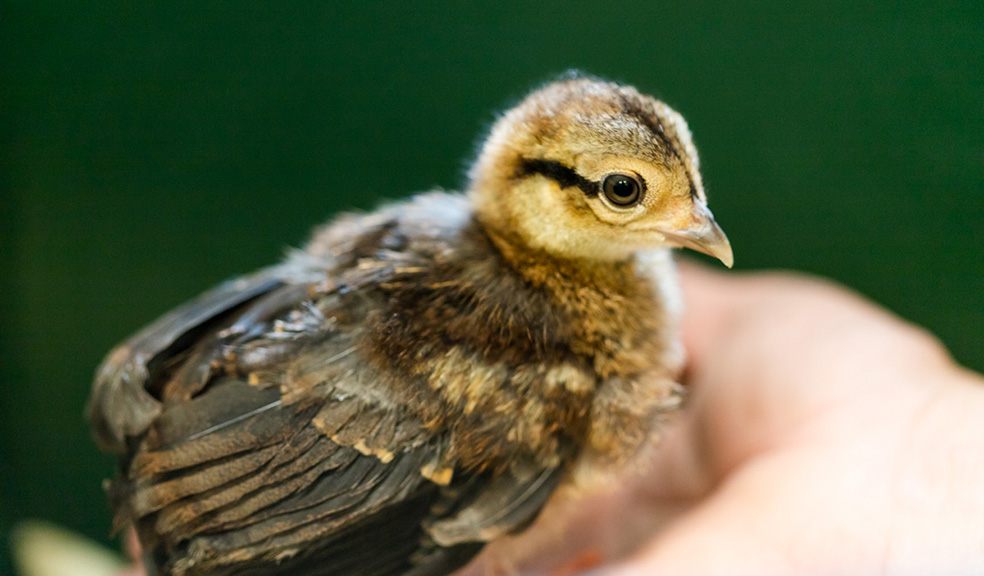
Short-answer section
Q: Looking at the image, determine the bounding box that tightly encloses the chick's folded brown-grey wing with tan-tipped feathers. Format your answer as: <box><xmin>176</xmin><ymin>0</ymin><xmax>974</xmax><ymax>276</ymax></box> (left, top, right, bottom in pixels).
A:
<box><xmin>100</xmin><ymin>200</ymin><xmax>561</xmax><ymax>576</ymax></box>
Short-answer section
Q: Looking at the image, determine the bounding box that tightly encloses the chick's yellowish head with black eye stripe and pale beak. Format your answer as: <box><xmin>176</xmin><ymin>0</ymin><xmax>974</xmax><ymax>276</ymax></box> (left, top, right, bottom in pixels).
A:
<box><xmin>470</xmin><ymin>77</ymin><xmax>732</xmax><ymax>266</ymax></box>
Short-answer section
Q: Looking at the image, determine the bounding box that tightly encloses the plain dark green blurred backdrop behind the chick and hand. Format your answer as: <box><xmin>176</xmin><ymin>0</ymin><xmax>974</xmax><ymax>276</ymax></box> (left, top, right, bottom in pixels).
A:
<box><xmin>0</xmin><ymin>0</ymin><xmax>984</xmax><ymax>573</ymax></box>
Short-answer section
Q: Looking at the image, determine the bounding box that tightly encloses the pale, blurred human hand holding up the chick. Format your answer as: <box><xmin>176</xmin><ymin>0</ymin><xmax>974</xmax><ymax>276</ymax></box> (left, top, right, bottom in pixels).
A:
<box><xmin>117</xmin><ymin>263</ymin><xmax>984</xmax><ymax>576</ymax></box>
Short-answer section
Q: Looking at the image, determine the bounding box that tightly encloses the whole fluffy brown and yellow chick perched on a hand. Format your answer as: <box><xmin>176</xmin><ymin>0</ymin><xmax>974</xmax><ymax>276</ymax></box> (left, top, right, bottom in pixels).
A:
<box><xmin>88</xmin><ymin>76</ymin><xmax>732</xmax><ymax>576</ymax></box>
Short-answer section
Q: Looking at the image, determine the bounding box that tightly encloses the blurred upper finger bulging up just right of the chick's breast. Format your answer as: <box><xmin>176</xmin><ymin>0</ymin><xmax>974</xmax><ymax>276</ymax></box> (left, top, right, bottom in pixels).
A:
<box><xmin>668</xmin><ymin>263</ymin><xmax>949</xmax><ymax>478</ymax></box>
